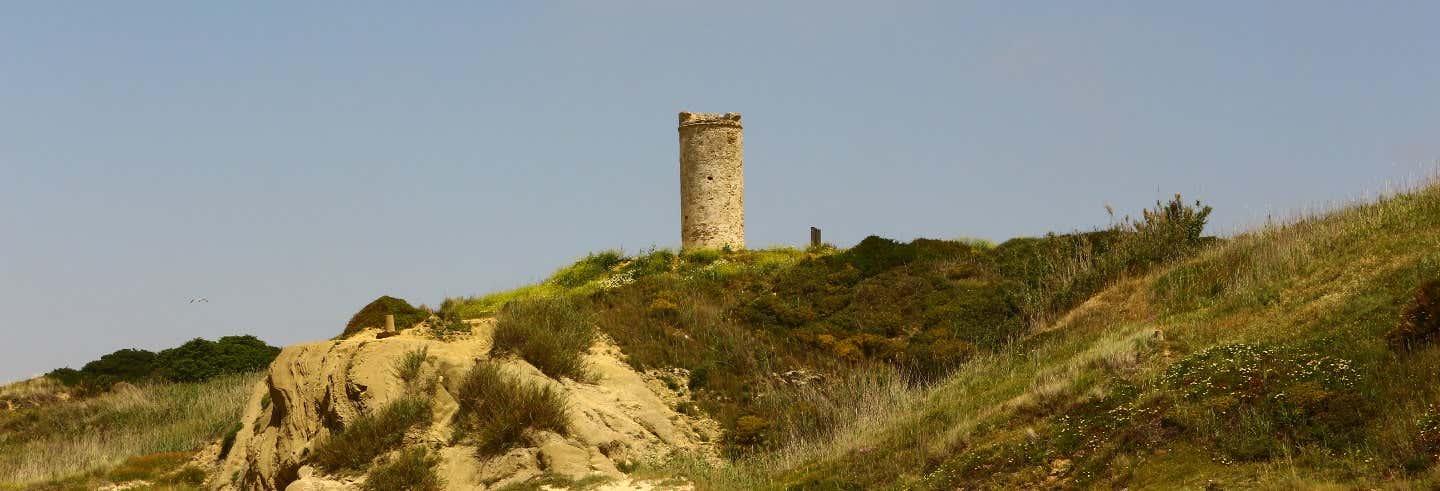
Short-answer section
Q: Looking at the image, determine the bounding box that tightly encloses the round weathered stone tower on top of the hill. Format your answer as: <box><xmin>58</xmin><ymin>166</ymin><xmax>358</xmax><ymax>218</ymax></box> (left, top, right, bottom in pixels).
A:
<box><xmin>680</xmin><ymin>112</ymin><xmax>744</xmax><ymax>249</ymax></box>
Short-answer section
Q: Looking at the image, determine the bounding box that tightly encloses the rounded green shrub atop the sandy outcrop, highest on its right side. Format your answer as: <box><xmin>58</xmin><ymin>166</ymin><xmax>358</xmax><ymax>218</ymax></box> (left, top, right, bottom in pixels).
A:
<box><xmin>494</xmin><ymin>297</ymin><xmax>595</xmax><ymax>380</ymax></box>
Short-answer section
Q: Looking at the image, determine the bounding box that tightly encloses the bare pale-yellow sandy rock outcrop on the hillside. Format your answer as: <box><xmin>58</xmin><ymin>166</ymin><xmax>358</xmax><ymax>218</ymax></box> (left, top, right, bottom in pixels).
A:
<box><xmin>213</xmin><ymin>321</ymin><xmax>719</xmax><ymax>490</ymax></box>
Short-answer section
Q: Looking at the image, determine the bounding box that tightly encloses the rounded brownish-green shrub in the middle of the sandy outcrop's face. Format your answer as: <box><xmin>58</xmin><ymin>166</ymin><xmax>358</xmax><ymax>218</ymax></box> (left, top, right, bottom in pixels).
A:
<box><xmin>455</xmin><ymin>361</ymin><xmax>570</xmax><ymax>456</ymax></box>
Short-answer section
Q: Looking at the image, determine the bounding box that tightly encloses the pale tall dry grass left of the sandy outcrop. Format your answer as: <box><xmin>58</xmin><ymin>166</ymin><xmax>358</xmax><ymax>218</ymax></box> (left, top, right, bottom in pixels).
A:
<box><xmin>0</xmin><ymin>373</ymin><xmax>264</xmax><ymax>485</ymax></box>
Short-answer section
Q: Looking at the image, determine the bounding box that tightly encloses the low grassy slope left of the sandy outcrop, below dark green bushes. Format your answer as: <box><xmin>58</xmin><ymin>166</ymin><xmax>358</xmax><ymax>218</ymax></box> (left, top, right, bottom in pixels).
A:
<box><xmin>0</xmin><ymin>374</ymin><xmax>259</xmax><ymax>490</ymax></box>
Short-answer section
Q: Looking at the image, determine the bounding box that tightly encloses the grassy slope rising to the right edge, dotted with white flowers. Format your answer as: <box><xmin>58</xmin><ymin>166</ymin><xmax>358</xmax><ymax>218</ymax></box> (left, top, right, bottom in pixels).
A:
<box><xmin>648</xmin><ymin>182</ymin><xmax>1440</xmax><ymax>490</ymax></box>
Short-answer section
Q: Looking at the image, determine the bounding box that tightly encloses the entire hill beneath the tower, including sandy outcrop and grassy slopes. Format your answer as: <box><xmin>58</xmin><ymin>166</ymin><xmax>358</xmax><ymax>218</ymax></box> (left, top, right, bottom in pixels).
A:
<box><xmin>0</xmin><ymin>186</ymin><xmax>1440</xmax><ymax>490</ymax></box>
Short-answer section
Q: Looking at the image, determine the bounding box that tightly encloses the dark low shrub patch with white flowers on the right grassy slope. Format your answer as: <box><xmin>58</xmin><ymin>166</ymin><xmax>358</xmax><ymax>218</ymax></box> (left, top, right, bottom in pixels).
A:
<box><xmin>1162</xmin><ymin>344</ymin><xmax>1369</xmax><ymax>459</ymax></box>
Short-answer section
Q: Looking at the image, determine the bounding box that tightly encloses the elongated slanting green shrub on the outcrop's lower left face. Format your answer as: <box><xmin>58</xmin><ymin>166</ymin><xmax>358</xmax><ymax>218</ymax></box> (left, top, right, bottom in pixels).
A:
<box><xmin>311</xmin><ymin>396</ymin><xmax>431</xmax><ymax>472</ymax></box>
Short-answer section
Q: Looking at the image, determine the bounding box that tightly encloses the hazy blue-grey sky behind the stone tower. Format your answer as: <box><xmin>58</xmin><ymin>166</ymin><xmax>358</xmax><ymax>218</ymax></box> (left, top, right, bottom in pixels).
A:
<box><xmin>0</xmin><ymin>1</ymin><xmax>1440</xmax><ymax>380</ymax></box>
